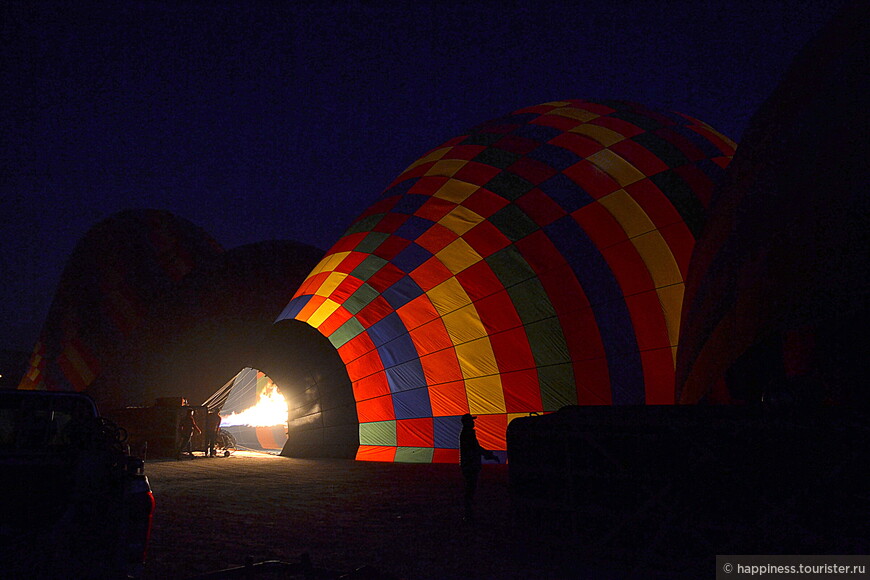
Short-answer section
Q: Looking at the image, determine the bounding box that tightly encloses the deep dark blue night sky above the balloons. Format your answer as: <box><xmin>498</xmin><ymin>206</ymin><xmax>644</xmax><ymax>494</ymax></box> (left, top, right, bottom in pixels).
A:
<box><xmin>0</xmin><ymin>0</ymin><xmax>843</xmax><ymax>351</ymax></box>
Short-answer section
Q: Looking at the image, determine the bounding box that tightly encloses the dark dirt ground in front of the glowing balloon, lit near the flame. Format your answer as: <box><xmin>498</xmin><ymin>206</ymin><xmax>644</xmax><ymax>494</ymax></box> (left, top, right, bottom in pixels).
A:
<box><xmin>144</xmin><ymin>452</ymin><xmax>623</xmax><ymax>580</ymax></box>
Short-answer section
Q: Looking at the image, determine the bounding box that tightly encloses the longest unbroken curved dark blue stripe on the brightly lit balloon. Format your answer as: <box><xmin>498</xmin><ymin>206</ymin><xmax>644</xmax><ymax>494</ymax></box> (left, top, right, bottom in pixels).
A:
<box><xmin>544</xmin><ymin>216</ymin><xmax>645</xmax><ymax>405</ymax></box>
